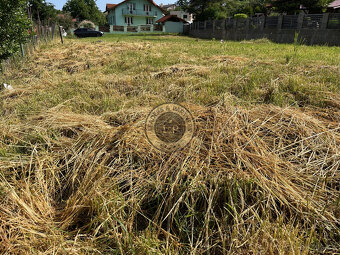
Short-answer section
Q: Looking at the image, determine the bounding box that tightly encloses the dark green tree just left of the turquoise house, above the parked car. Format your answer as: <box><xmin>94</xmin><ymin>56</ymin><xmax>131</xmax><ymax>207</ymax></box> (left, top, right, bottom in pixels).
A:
<box><xmin>63</xmin><ymin>0</ymin><xmax>106</xmax><ymax>25</ymax></box>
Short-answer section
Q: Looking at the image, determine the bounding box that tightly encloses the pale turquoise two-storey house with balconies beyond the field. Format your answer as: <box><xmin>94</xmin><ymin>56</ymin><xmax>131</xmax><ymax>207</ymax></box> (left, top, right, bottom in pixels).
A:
<box><xmin>106</xmin><ymin>0</ymin><xmax>165</xmax><ymax>26</ymax></box>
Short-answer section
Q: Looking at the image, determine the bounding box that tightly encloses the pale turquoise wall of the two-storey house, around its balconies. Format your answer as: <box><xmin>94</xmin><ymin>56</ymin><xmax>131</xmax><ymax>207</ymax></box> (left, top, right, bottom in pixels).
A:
<box><xmin>107</xmin><ymin>0</ymin><xmax>163</xmax><ymax>26</ymax></box>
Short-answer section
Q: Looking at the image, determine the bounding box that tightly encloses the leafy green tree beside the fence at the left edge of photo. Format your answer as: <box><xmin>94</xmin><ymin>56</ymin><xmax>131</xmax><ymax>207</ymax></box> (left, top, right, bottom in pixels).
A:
<box><xmin>0</xmin><ymin>0</ymin><xmax>30</xmax><ymax>60</ymax></box>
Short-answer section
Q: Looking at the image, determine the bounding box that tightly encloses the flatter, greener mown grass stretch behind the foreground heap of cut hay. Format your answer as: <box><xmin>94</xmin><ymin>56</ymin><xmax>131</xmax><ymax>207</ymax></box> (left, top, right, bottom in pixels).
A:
<box><xmin>0</xmin><ymin>35</ymin><xmax>340</xmax><ymax>114</ymax></box>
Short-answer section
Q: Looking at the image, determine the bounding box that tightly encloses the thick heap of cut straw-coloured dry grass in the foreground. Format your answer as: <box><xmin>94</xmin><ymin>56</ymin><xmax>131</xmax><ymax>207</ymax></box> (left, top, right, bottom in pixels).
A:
<box><xmin>0</xmin><ymin>102</ymin><xmax>340</xmax><ymax>254</ymax></box>
